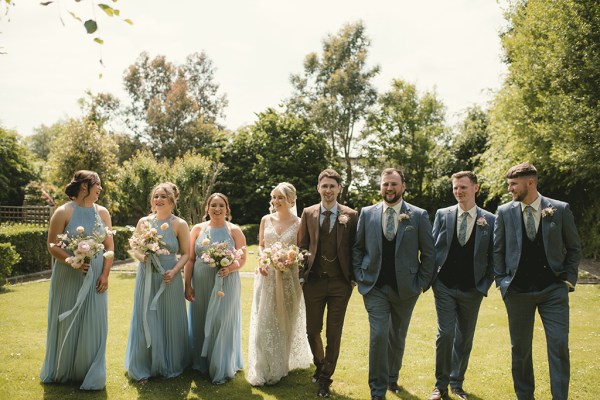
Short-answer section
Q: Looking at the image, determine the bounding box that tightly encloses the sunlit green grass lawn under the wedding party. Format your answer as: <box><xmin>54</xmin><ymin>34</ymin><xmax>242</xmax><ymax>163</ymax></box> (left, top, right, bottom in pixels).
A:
<box><xmin>0</xmin><ymin>268</ymin><xmax>600</xmax><ymax>400</ymax></box>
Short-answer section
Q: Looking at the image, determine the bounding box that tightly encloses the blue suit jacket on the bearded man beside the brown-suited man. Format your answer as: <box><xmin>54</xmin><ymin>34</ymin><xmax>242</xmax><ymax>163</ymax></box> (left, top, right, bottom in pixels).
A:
<box><xmin>352</xmin><ymin>202</ymin><xmax>435</xmax><ymax>299</ymax></box>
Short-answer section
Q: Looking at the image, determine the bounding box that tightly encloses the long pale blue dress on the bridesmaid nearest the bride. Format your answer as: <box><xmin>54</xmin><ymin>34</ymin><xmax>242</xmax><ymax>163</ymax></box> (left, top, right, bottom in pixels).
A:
<box><xmin>188</xmin><ymin>223</ymin><xmax>244</xmax><ymax>384</ymax></box>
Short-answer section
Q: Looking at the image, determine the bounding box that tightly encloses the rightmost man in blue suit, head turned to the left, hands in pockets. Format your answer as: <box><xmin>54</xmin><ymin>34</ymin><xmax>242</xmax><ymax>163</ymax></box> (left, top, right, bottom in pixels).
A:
<box><xmin>494</xmin><ymin>163</ymin><xmax>581</xmax><ymax>400</ymax></box>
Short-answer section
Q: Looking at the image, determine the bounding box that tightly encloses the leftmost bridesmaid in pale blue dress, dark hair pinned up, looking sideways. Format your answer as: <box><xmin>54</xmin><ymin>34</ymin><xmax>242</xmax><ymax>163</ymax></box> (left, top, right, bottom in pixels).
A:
<box><xmin>41</xmin><ymin>170</ymin><xmax>114</xmax><ymax>390</ymax></box>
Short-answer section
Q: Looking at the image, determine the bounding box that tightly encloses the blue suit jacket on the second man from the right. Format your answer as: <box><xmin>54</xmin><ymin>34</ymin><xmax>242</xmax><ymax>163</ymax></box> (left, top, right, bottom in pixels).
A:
<box><xmin>432</xmin><ymin>205</ymin><xmax>496</xmax><ymax>296</ymax></box>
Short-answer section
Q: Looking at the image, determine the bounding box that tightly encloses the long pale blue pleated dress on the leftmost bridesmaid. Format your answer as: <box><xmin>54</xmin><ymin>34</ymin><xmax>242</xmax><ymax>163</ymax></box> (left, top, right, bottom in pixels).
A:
<box><xmin>40</xmin><ymin>202</ymin><xmax>108</xmax><ymax>390</ymax></box>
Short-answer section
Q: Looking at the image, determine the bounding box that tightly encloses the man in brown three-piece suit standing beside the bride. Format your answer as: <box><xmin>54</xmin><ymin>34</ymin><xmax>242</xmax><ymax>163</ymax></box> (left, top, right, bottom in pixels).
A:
<box><xmin>298</xmin><ymin>169</ymin><xmax>358</xmax><ymax>397</ymax></box>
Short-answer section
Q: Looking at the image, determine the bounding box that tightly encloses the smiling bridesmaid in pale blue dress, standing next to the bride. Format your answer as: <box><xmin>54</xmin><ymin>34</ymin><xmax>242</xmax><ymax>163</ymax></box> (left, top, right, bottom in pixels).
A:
<box><xmin>185</xmin><ymin>193</ymin><xmax>246</xmax><ymax>384</ymax></box>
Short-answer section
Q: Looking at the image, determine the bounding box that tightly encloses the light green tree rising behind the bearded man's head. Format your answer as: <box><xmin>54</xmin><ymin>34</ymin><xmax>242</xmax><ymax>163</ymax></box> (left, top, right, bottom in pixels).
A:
<box><xmin>365</xmin><ymin>79</ymin><xmax>448</xmax><ymax>206</ymax></box>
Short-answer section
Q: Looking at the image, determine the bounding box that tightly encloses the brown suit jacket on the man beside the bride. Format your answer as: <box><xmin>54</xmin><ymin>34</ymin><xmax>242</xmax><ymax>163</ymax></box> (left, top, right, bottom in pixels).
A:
<box><xmin>298</xmin><ymin>203</ymin><xmax>358</xmax><ymax>282</ymax></box>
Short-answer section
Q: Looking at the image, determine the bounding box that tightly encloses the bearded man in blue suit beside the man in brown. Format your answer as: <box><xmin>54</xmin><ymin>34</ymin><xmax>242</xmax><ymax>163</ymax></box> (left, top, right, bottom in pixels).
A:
<box><xmin>352</xmin><ymin>168</ymin><xmax>435</xmax><ymax>400</ymax></box>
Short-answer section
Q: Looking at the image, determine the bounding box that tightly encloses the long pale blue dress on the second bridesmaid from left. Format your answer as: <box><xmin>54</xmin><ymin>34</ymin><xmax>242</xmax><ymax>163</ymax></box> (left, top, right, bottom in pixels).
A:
<box><xmin>125</xmin><ymin>218</ymin><xmax>190</xmax><ymax>381</ymax></box>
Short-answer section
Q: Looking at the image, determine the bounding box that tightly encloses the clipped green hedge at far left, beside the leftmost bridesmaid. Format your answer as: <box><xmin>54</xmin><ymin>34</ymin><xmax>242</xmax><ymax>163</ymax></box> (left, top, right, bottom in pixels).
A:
<box><xmin>0</xmin><ymin>224</ymin><xmax>50</xmax><ymax>276</ymax></box>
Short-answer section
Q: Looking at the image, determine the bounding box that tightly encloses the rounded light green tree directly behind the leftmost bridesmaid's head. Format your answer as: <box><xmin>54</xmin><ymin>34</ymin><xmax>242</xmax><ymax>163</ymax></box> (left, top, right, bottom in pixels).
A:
<box><xmin>45</xmin><ymin>119</ymin><xmax>118</xmax><ymax>212</ymax></box>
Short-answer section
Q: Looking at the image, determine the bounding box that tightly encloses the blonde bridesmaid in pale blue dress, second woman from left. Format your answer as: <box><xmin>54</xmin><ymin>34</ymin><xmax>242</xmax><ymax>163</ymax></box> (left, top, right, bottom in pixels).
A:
<box><xmin>125</xmin><ymin>182</ymin><xmax>190</xmax><ymax>384</ymax></box>
